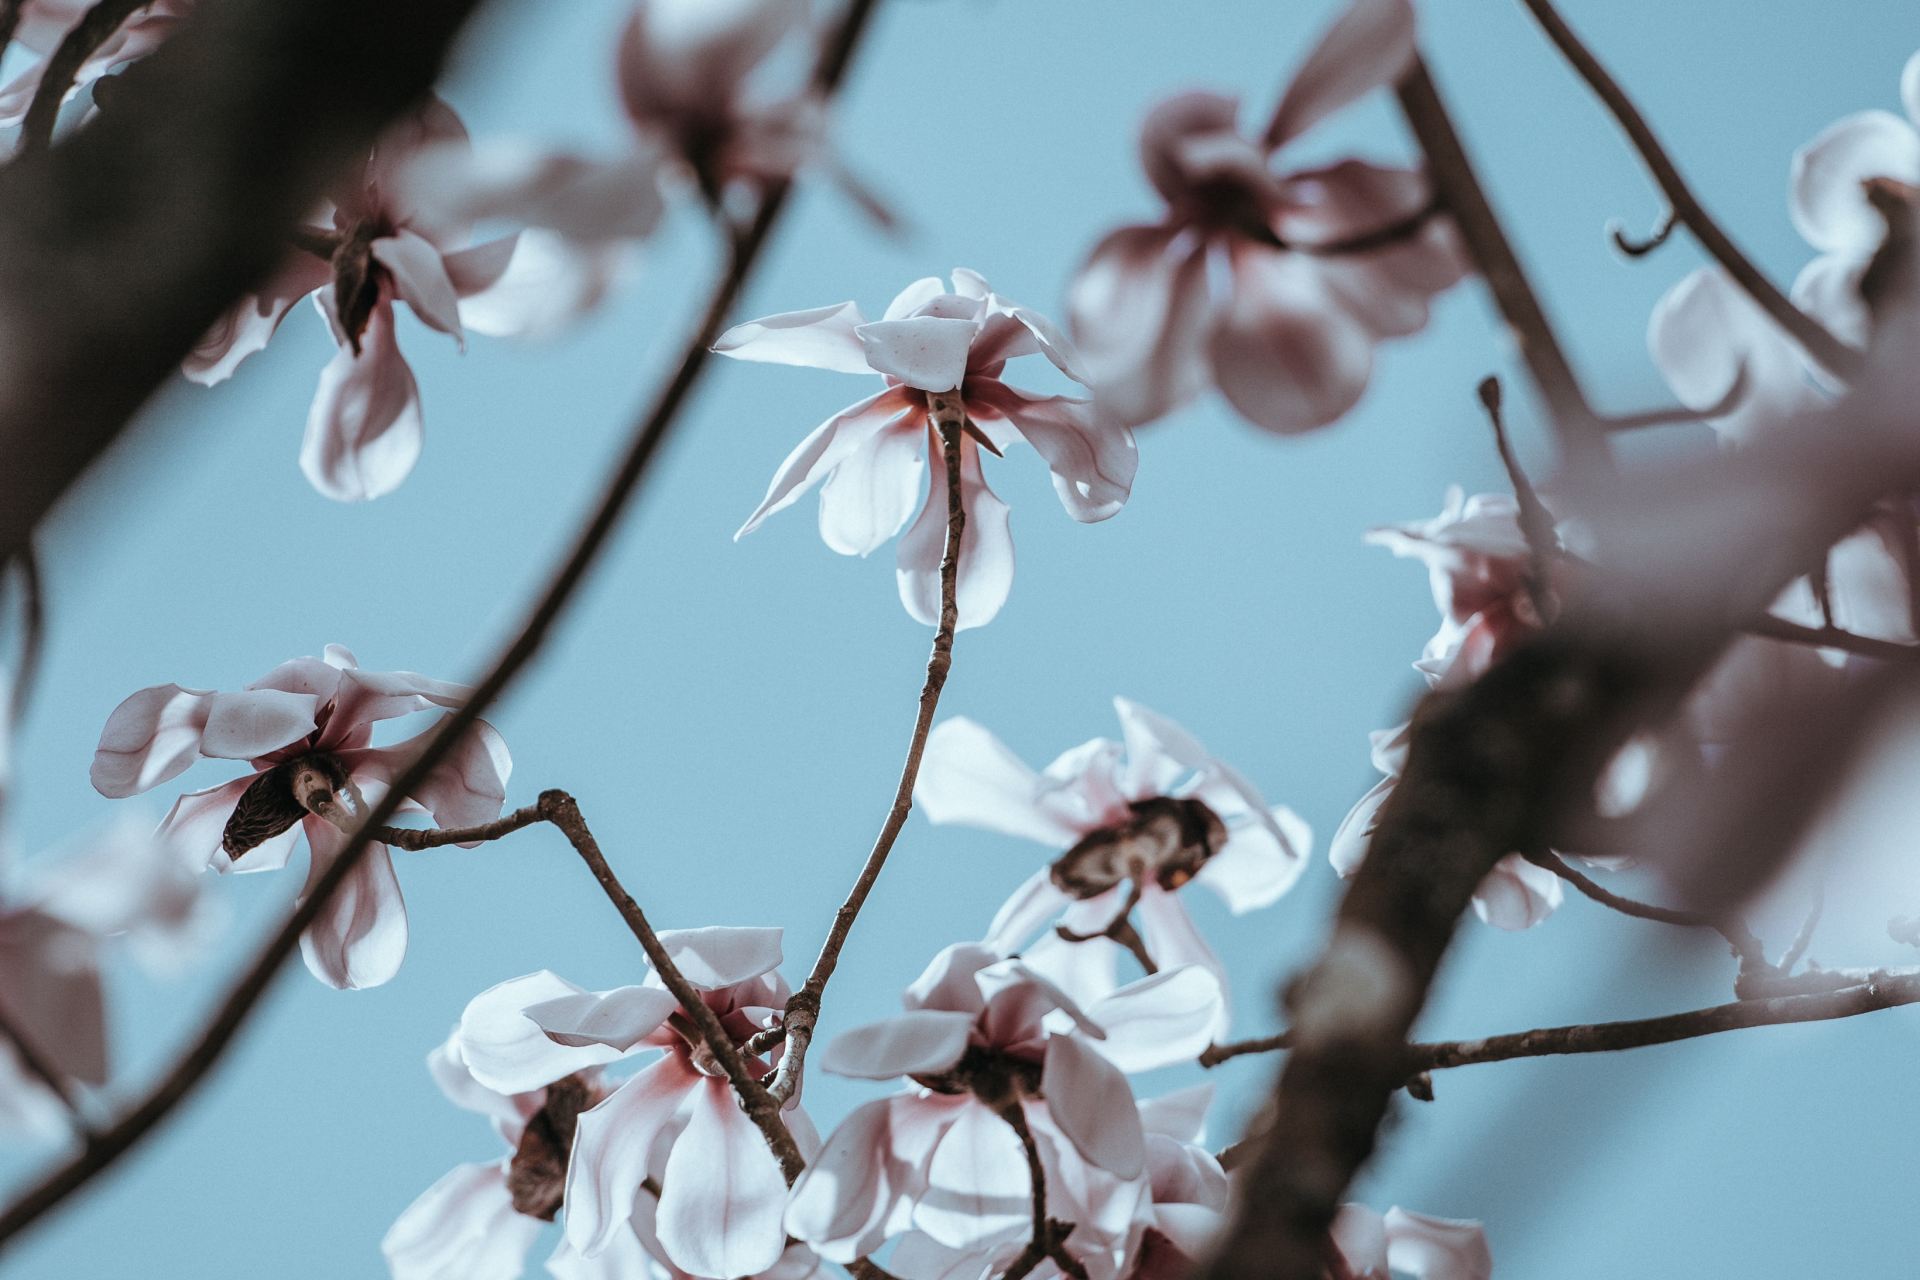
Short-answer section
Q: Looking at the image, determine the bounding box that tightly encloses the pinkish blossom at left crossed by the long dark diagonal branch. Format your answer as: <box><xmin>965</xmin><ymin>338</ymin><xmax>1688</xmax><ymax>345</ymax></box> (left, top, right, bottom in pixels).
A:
<box><xmin>92</xmin><ymin>645</ymin><xmax>513</xmax><ymax>986</ymax></box>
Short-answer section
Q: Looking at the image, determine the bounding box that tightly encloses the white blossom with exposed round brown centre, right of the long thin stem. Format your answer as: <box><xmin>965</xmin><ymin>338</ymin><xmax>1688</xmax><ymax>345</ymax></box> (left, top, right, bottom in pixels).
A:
<box><xmin>914</xmin><ymin>699</ymin><xmax>1313</xmax><ymax>1000</ymax></box>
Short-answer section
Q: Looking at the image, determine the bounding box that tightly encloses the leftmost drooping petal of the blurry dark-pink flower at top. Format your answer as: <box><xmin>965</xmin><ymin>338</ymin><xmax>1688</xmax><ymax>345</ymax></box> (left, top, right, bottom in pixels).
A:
<box><xmin>1068</xmin><ymin>226</ymin><xmax>1212</xmax><ymax>426</ymax></box>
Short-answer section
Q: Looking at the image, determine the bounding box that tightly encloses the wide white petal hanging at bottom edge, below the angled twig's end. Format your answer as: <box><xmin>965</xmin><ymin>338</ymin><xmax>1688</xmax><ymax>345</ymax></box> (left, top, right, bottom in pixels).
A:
<box><xmin>655</xmin><ymin>1080</ymin><xmax>787</xmax><ymax>1276</ymax></box>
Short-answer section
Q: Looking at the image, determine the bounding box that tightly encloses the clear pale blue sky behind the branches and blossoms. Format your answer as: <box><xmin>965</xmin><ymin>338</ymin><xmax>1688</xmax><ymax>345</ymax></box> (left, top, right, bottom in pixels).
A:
<box><xmin>4</xmin><ymin>0</ymin><xmax>1920</xmax><ymax>1280</ymax></box>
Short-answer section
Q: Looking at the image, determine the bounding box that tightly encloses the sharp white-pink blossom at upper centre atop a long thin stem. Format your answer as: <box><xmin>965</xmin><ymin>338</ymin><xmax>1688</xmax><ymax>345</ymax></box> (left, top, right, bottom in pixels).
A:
<box><xmin>714</xmin><ymin>269</ymin><xmax>1139</xmax><ymax>628</ymax></box>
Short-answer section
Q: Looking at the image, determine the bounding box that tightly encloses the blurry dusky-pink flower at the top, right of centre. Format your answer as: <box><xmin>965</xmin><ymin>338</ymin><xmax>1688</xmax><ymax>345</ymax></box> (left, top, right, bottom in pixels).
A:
<box><xmin>1068</xmin><ymin>0</ymin><xmax>1467</xmax><ymax>432</ymax></box>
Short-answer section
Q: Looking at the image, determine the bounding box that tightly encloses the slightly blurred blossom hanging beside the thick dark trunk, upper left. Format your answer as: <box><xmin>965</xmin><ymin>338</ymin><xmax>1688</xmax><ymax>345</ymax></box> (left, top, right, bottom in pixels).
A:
<box><xmin>184</xmin><ymin>100</ymin><xmax>607</xmax><ymax>503</ymax></box>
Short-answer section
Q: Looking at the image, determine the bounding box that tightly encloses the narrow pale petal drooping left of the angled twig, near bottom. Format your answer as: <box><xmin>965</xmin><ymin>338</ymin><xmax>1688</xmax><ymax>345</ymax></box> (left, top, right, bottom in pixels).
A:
<box><xmin>566</xmin><ymin>1054</ymin><xmax>707</xmax><ymax>1257</ymax></box>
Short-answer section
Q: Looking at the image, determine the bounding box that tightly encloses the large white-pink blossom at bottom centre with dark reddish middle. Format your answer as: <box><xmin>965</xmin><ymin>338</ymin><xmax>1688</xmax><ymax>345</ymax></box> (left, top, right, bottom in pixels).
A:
<box><xmin>785</xmin><ymin>942</ymin><xmax>1219</xmax><ymax>1276</ymax></box>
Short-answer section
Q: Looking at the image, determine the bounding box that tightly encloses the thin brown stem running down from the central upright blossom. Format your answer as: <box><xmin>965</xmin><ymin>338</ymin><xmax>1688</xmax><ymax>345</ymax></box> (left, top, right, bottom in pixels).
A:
<box><xmin>774</xmin><ymin>408</ymin><xmax>966</xmax><ymax>1102</ymax></box>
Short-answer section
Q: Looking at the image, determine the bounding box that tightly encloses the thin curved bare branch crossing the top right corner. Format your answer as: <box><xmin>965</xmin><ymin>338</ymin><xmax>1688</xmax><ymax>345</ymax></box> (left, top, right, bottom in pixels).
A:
<box><xmin>1521</xmin><ymin>0</ymin><xmax>1860</xmax><ymax>378</ymax></box>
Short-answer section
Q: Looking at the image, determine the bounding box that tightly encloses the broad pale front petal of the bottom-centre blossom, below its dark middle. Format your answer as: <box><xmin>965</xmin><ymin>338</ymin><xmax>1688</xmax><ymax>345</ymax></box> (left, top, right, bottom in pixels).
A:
<box><xmin>914</xmin><ymin>1098</ymin><xmax>1036</xmax><ymax>1249</ymax></box>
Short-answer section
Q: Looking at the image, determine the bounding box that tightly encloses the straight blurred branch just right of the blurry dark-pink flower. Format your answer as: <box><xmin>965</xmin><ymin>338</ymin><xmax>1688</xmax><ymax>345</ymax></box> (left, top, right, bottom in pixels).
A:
<box><xmin>1398</xmin><ymin>59</ymin><xmax>1607</xmax><ymax>464</ymax></box>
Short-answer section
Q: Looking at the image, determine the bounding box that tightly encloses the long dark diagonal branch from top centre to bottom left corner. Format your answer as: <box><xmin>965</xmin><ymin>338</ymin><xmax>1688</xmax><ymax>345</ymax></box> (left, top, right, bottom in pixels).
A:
<box><xmin>0</xmin><ymin>0</ymin><xmax>877</xmax><ymax>1244</ymax></box>
